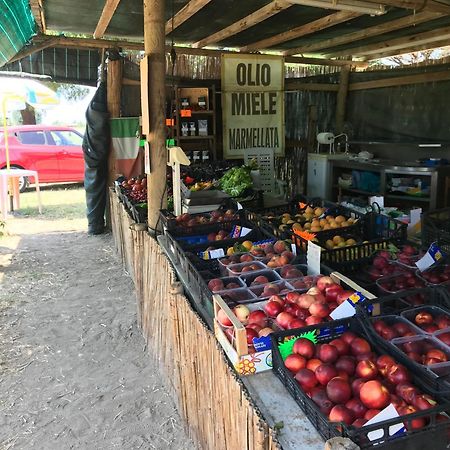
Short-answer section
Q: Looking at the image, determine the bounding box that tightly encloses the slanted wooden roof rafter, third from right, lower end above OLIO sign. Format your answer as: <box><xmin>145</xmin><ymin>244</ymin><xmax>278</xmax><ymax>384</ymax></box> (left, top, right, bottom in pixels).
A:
<box><xmin>240</xmin><ymin>11</ymin><xmax>361</xmax><ymax>52</ymax></box>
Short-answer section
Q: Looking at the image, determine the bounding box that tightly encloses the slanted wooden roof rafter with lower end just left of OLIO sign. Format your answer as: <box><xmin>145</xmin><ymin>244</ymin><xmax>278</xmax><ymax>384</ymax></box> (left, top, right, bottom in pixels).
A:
<box><xmin>193</xmin><ymin>0</ymin><xmax>292</xmax><ymax>48</ymax></box>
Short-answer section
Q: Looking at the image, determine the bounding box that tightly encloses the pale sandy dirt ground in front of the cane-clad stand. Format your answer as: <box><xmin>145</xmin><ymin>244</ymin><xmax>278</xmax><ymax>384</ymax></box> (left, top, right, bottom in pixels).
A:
<box><xmin>0</xmin><ymin>190</ymin><xmax>195</xmax><ymax>450</ymax></box>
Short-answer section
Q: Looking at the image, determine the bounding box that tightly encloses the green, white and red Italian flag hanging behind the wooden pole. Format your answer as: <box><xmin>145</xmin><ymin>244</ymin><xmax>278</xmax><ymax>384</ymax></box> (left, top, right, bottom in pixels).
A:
<box><xmin>110</xmin><ymin>117</ymin><xmax>143</xmax><ymax>178</ymax></box>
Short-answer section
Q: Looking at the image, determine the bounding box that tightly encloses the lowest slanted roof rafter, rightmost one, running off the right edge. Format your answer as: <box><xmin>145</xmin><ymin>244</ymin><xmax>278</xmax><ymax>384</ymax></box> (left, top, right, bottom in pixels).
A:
<box><xmin>330</xmin><ymin>27</ymin><xmax>450</xmax><ymax>57</ymax></box>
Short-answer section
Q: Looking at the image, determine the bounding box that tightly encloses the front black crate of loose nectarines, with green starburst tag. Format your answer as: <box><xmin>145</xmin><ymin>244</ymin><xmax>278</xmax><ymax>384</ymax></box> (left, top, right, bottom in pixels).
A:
<box><xmin>271</xmin><ymin>317</ymin><xmax>450</xmax><ymax>450</ymax></box>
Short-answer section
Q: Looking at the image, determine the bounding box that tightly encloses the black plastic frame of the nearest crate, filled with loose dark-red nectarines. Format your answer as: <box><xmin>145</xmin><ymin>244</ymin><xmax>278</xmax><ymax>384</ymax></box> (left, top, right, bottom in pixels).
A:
<box><xmin>271</xmin><ymin>317</ymin><xmax>450</xmax><ymax>450</ymax></box>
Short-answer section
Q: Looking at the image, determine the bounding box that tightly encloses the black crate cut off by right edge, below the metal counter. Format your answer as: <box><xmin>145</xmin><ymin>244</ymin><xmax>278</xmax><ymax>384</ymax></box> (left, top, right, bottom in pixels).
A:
<box><xmin>422</xmin><ymin>208</ymin><xmax>450</xmax><ymax>254</ymax></box>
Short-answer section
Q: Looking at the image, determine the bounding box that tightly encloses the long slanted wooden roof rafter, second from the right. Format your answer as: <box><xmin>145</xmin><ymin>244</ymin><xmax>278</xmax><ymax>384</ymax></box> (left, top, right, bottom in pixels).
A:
<box><xmin>284</xmin><ymin>11</ymin><xmax>442</xmax><ymax>55</ymax></box>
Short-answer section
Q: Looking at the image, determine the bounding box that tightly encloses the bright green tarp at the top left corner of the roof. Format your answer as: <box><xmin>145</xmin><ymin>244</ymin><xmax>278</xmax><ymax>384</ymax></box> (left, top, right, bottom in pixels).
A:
<box><xmin>0</xmin><ymin>0</ymin><xmax>36</xmax><ymax>67</ymax></box>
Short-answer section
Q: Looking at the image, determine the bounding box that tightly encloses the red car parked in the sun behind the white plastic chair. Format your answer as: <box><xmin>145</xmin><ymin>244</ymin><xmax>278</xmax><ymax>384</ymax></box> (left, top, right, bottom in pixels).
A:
<box><xmin>0</xmin><ymin>125</ymin><xmax>84</xmax><ymax>192</ymax></box>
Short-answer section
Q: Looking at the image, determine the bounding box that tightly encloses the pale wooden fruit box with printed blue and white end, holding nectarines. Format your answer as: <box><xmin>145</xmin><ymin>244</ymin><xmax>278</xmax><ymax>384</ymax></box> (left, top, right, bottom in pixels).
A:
<box><xmin>212</xmin><ymin>267</ymin><xmax>373</xmax><ymax>375</ymax></box>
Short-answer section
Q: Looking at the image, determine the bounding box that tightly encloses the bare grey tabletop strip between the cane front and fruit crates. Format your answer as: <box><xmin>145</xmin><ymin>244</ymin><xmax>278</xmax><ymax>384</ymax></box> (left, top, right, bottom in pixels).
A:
<box><xmin>158</xmin><ymin>236</ymin><xmax>324</xmax><ymax>450</ymax></box>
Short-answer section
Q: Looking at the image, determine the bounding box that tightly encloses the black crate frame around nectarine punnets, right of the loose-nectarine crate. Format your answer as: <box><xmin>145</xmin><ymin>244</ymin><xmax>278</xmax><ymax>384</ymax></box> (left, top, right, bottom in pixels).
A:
<box><xmin>356</xmin><ymin>288</ymin><xmax>450</xmax><ymax>399</ymax></box>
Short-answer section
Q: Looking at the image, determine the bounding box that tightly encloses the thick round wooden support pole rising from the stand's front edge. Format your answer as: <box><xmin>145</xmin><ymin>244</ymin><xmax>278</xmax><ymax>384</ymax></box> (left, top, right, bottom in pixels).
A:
<box><xmin>144</xmin><ymin>0</ymin><xmax>167</xmax><ymax>230</ymax></box>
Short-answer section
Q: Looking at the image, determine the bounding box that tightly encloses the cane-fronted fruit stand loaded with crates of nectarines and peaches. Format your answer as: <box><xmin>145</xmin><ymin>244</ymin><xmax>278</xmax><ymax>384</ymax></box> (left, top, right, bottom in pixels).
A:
<box><xmin>111</xmin><ymin>186</ymin><xmax>450</xmax><ymax>450</ymax></box>
